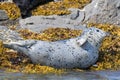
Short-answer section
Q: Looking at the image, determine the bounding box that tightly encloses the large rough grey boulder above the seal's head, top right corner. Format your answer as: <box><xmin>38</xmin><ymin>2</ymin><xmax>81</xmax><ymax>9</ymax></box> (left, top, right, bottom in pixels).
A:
<box><xmin>83</xmin><ymin>0</ymin><xmax>120</xmax><ymax>25</ymax></box>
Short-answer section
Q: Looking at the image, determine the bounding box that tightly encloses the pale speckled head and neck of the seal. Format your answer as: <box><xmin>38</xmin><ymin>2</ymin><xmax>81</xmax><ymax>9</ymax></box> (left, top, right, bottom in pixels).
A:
<box><xmin>83</xmin><ymin>27</ymin><xmax>109</xmax><ymax>47</ymax></box>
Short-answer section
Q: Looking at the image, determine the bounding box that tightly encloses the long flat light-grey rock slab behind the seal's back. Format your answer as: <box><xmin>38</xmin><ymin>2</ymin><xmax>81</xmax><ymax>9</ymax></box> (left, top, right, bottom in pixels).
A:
<box><xmin>19</xmin><ymin>8</ymin><xmax>85</xmax><ymax>32</ymax></box>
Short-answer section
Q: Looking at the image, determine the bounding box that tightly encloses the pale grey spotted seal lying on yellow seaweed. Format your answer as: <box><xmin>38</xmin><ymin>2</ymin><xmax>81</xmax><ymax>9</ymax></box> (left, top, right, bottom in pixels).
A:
<box><xmin>4</xmin><ymin>27</ymin><xmax>107</xmax><ymax>68</ymax></box>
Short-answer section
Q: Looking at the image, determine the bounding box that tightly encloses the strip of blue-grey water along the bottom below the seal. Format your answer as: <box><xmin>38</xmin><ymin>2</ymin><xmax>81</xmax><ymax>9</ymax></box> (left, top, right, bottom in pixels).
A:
<box><xmin>0</xmin><ymin>71</ymin><xmax>120</xmax><ymax>80</ymax></box>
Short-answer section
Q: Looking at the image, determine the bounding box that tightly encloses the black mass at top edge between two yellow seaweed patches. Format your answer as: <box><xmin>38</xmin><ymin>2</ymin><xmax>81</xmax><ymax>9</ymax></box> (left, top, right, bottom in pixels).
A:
<box><xmin>13</xmin><ymin>0</ymin><xmax>61</xmax><ymax>19</ymax></box>
